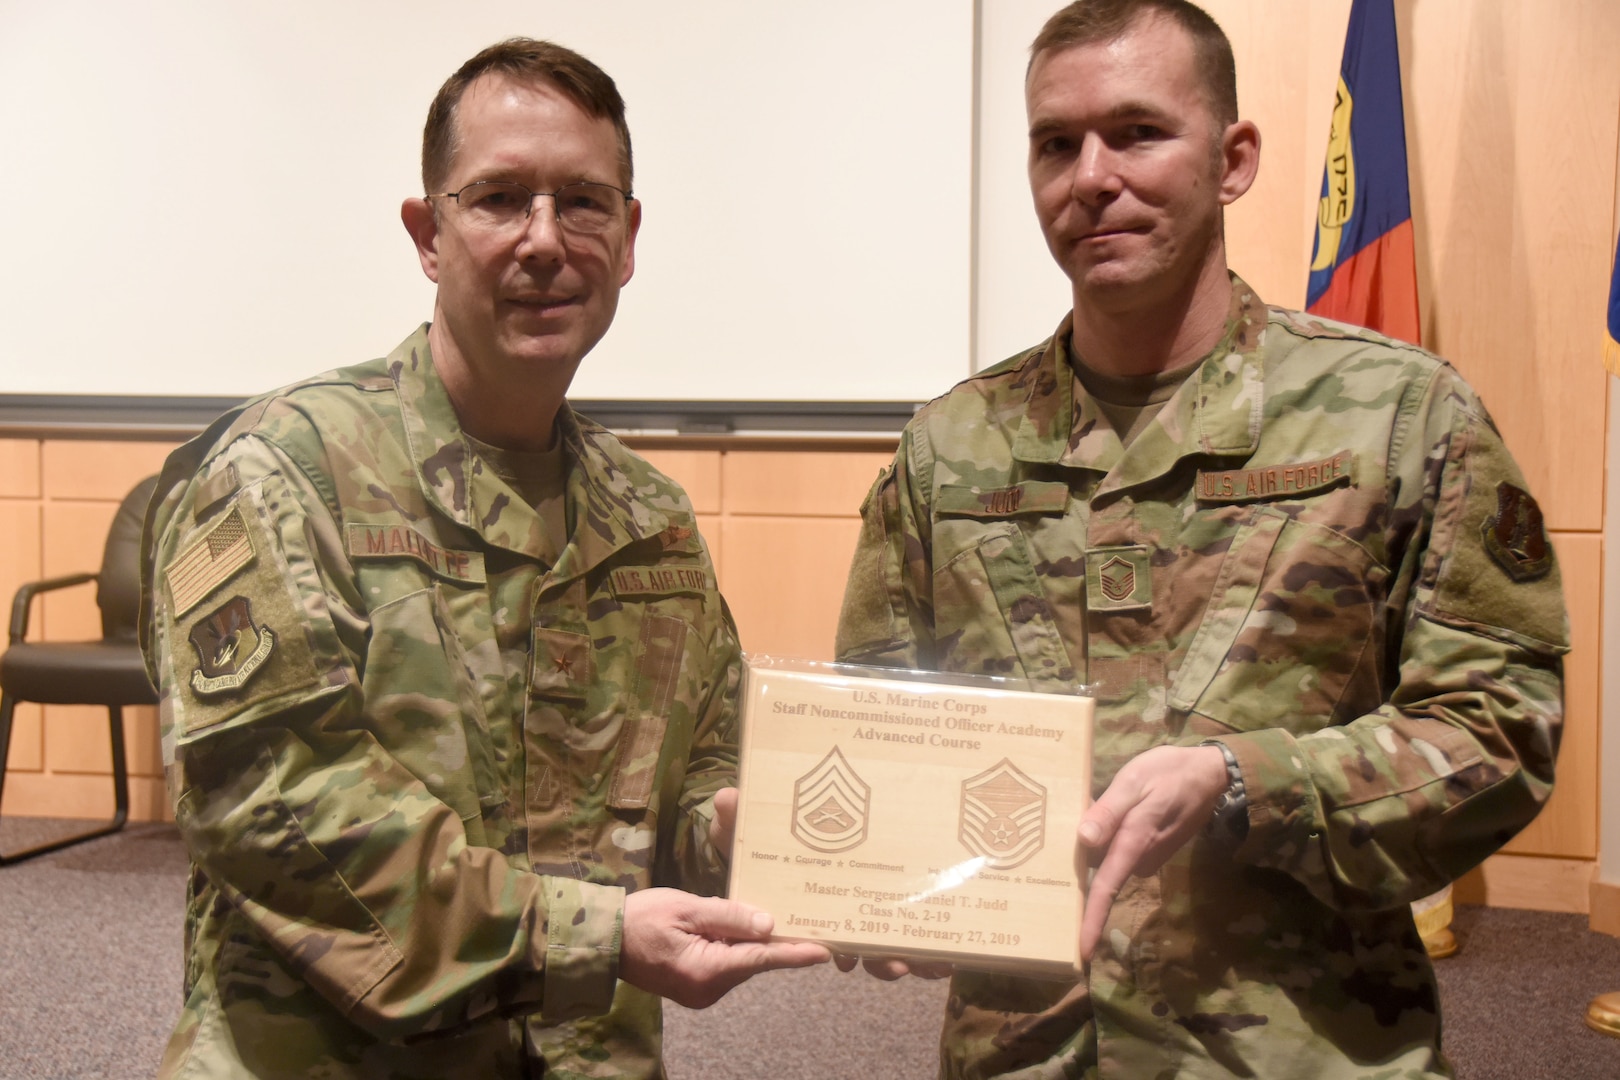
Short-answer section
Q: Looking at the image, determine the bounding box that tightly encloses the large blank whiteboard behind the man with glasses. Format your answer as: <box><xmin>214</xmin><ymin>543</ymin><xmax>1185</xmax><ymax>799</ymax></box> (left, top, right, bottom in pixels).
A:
<box><xmin>0</xmin><ymin>0</ymin><xmax>974</xmax><ymax>402</ymax></box>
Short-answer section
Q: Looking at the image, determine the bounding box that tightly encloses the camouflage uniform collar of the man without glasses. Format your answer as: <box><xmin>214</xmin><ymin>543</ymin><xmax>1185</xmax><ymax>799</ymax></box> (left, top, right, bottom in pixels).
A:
<box><xmin>1013</xmin><ymin>274</ymin><xmax>1267</xmax><ymax>494</ymax></box>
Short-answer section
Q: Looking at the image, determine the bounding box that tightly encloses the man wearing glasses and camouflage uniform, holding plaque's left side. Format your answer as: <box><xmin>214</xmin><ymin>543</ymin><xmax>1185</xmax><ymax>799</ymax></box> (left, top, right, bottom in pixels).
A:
<box><xmin>146</xmin><ymin>39</ymin><xmax>828</xmax><ymax>1078</ymax></box>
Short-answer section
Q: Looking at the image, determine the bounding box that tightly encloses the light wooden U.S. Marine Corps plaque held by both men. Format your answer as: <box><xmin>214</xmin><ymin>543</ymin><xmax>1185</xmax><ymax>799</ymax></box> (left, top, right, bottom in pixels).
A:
<box><xmin>731</xmin><ymin>657</ymin><xmax>1094</xmax><ymax>976</ymax></box>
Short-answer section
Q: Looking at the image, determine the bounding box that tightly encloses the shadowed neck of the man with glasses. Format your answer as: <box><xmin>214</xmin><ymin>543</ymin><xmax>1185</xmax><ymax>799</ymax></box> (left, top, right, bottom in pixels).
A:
<box><xmin>428</xmin><ymin>313</ymin><xmax>572</xmax><ymax>450</ymax></box>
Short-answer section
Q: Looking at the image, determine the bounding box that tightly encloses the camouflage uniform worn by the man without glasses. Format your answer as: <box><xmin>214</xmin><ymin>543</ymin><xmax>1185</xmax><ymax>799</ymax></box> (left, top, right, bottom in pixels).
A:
<box><xmin>839</xmin><ymin>279</ymin><xmax>1567</xmax><ymax>1078</ymax></box>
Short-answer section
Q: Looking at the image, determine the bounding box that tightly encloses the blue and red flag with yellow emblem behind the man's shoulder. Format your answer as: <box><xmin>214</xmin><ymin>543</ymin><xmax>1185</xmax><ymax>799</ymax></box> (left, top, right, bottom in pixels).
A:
<box><xmin>1306</xmin><ymin>0</ymin><xmax>1421</xmax><ymax>343</ymax></box>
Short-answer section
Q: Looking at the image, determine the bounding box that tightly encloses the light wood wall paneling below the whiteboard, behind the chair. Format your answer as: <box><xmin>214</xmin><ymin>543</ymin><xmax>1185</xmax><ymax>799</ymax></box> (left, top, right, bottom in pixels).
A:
<box><xmin>0</xmin><ymin>439</ymin><xmax>893</xmax><ymax>821</ymax></box>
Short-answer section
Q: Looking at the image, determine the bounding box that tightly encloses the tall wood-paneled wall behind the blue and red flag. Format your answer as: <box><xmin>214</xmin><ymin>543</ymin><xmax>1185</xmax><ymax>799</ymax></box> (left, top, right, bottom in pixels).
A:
<box><xmin>1205</xmin><ymin>0</ymin><xmax>1620</xmax><ymax>893</ymax></box>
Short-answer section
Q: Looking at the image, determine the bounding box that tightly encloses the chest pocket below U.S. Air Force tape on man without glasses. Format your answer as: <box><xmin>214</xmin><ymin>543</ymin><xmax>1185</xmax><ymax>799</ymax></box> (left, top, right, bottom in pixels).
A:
<box><xmin>1170</xmin><ymin>507</ymin><xmax>1388</xmax><ymax>735</ymax></box>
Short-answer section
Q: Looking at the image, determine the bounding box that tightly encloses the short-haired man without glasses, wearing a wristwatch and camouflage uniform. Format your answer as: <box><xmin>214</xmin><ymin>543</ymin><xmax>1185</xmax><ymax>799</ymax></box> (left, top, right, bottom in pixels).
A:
<box><xmin>838</xmin><ymin>0</ymin><xmax>1567</xmax><ymax>1078</ymax></box>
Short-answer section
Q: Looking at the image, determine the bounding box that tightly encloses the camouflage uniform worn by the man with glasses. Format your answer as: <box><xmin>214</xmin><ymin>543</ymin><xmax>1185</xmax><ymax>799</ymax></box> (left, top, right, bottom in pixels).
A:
<box><xmin>144</xmin><ymin>329</ymin><xmax>740</xmax><ymax>1078</ymax></box>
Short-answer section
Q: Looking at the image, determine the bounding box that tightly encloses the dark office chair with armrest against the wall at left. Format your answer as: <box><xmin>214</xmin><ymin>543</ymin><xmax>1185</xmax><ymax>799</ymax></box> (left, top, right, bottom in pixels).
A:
<box><xmin>0</xmin><ymin>476</ymin><xmax>157</xmax><ymax>866</ymax></box>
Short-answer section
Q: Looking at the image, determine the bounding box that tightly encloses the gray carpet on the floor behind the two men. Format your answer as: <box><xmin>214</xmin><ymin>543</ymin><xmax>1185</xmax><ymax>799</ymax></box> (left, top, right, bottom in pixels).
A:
<box><xmin>0</xmin><ymin>819</ymin><xmax>1620</xmax><ymax>1080</ymax></box>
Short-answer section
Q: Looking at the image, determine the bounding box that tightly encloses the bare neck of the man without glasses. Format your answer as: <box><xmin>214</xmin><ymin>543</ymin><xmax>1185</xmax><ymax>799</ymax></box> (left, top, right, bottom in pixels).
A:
<box><xmin>1074</xmin><ymin>257</ymin><xmax>1231</xmax><ymax>376</ymax></box>
